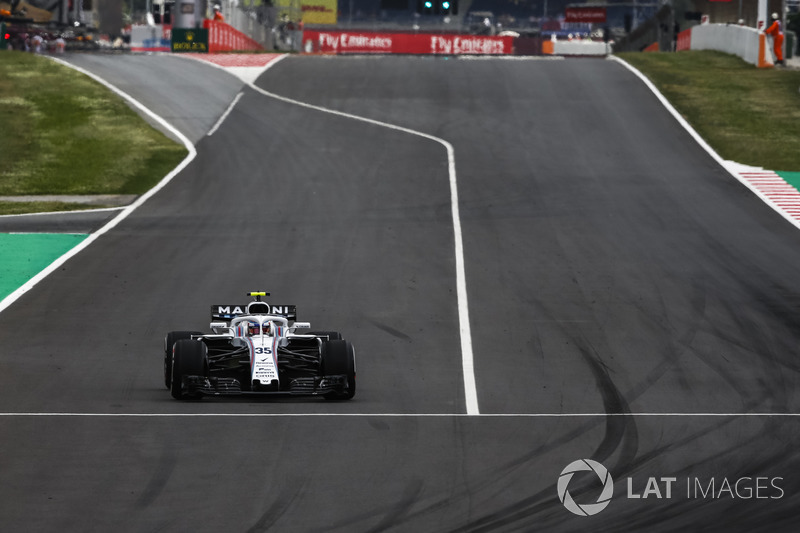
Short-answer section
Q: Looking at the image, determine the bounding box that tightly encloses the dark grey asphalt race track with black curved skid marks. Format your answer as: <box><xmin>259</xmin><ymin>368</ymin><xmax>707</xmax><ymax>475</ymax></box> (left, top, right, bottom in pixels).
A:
<box><xmin>0</xmin><ymin>56</ymin><xmax>800</xmax><ymax>532</ymax></box>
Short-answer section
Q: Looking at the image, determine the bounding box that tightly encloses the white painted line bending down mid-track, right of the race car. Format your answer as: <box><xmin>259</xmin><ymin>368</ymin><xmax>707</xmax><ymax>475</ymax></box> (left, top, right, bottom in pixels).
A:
<box><xmin>248</xmin><ymin>66</ymin><xmax>480</xmax><ymax>415</ymax></box>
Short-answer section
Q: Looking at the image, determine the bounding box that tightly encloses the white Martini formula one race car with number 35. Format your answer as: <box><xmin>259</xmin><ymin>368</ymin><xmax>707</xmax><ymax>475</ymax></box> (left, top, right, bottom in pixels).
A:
<box><xmin>164</xmin><ymin>292</ymin><xmax>356</xmax><ymax>400</ymax></box>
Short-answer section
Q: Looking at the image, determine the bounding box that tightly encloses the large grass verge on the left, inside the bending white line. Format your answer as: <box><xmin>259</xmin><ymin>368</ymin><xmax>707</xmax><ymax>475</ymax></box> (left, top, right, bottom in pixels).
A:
<box><xmin>0</xmin><ymin>50</ymin><xmax>187</xmax><ymax>213</ymax></box>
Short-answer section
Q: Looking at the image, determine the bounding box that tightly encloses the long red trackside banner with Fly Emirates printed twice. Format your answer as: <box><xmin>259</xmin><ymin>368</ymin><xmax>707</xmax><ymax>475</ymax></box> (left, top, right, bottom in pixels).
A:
<box><xmin>303</xmin><ymin>30</ymin><xmax>514</xmax><ymax>55</ymax></box>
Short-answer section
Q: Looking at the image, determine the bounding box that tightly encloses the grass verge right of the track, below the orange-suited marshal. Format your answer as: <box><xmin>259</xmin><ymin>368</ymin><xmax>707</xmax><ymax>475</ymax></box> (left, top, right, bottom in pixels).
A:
<box><xmin>617</xmin><ymin>51</ymin><xmax>800</xmax><ymax>171</ymax></box>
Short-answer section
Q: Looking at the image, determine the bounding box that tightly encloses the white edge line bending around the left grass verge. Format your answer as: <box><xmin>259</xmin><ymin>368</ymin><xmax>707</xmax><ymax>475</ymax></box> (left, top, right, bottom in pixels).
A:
<box><xmin>0</xmin><ymin>57</ymin><xmax>197</xmax><ymax>313</ymax></box>
